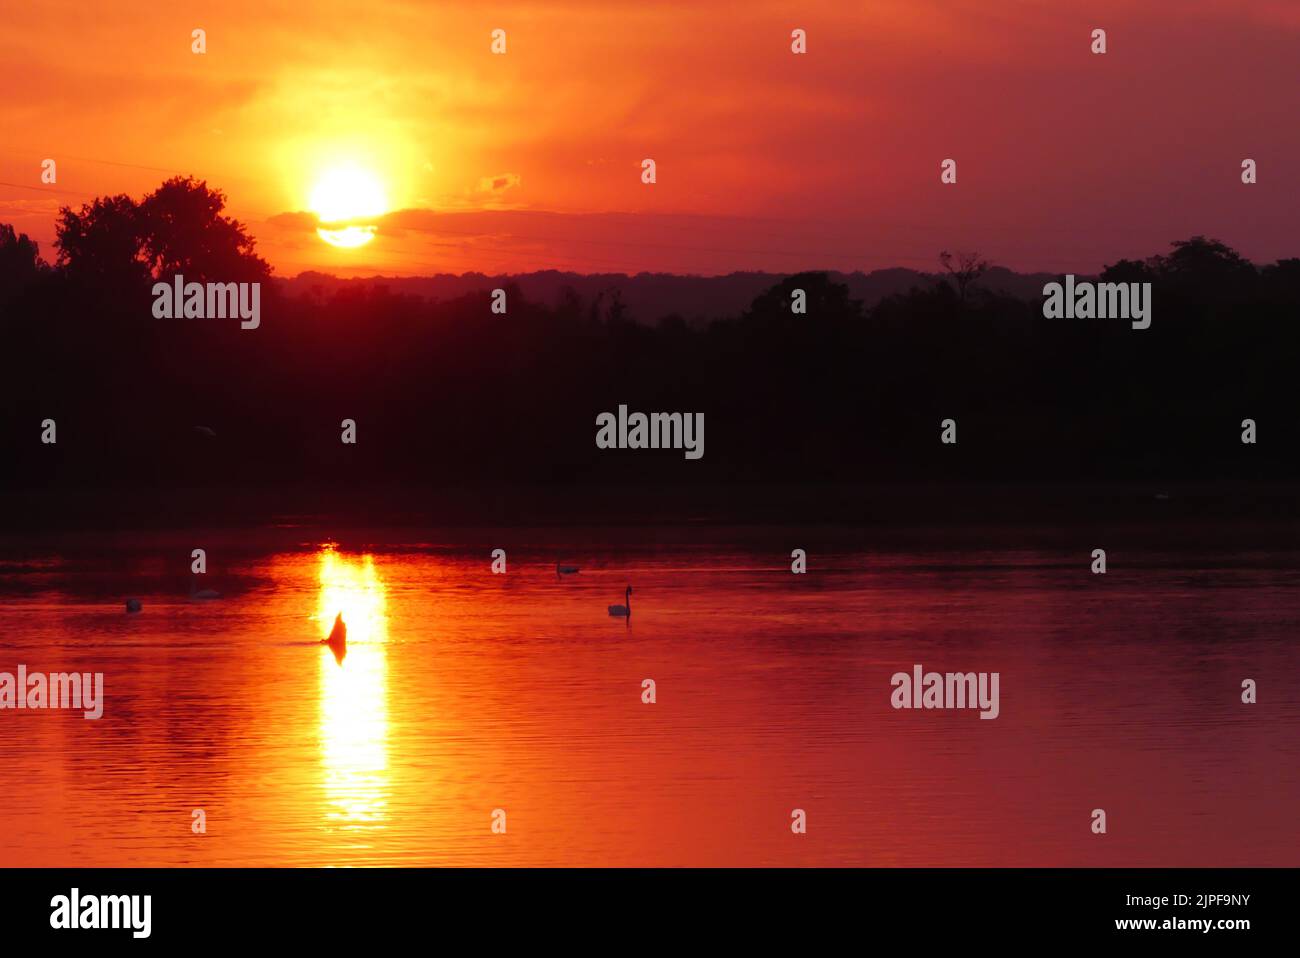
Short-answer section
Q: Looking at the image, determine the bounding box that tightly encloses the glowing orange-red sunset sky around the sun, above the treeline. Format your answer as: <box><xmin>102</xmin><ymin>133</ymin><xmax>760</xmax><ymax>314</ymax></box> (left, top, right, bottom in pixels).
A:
<box><xmin>0</xmin><ymin>0</ymin><xmax>1300</xmax><ymax>276</ymax></box>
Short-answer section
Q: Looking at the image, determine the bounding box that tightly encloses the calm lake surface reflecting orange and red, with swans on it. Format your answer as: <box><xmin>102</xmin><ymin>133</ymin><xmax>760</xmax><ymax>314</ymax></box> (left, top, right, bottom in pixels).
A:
<box><xmin>0</xmin><ymin>528</ymin><xmax>1300</xmax><ymax>866</ymax></box>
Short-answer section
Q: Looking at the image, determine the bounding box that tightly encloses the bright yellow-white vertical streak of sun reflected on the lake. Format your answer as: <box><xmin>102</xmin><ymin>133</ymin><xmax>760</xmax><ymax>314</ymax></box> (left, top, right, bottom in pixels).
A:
<box><xmin>315</xmin><ymin>546</ymin><xmax>390</xmax><ymax>828</ymax></box>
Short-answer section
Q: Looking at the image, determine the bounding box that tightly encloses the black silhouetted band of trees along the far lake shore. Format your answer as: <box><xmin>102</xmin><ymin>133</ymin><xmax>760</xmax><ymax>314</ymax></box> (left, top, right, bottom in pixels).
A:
<box><xmin>0</xmin><ymin>179</ymin><xmax>1300</xmax><ymax>509</ymax></box>
